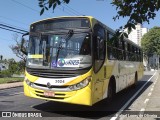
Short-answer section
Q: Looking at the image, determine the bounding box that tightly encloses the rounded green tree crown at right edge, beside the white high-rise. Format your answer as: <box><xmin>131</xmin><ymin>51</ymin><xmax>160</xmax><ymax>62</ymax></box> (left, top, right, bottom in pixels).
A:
<box><xmin>141</xmin><ymin>27</ymin><xmax>160</xmax><ymax>57</ymax></box>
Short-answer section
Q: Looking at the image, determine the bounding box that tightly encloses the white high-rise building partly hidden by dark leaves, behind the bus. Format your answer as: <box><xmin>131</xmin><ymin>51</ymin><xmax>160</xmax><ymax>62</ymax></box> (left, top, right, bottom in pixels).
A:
<box><xmin>128</xmin><ymin>24</ymin><xmax>149</xmax><ymax>46</ymax></box>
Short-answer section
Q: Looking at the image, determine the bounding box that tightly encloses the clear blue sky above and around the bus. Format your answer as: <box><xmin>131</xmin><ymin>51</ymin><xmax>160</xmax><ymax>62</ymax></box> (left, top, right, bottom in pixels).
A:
<box><xmin>0</xmin><ymin>0</ymin><xmax>160</xmax><ymax>61</ymax></box>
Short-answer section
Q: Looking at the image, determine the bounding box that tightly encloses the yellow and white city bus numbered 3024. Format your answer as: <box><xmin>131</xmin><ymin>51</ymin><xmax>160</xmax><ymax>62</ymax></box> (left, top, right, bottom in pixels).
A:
<box><xmin>22</xmin><ymin>16</ymin><xmax>143</xmax><ymax>106</ymax></box>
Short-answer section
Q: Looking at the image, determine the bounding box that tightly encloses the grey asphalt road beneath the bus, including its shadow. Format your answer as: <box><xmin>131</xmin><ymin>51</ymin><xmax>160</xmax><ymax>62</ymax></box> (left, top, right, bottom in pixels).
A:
<box><xmin>0</xmin><ymin>72</ymin><xmax>155</xmax><ymax>120</ymax></box>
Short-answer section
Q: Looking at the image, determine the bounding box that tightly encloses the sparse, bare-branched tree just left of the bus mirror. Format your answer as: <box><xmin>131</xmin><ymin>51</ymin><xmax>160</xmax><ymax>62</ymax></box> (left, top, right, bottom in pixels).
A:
<box><xmin>9</xmin><ymin>34</ymin><xmax>27</xmax><ymax>62</ymax></box>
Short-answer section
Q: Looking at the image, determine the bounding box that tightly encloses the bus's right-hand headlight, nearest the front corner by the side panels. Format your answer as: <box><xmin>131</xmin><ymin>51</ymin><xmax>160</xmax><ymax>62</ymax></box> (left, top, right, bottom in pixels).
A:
<box><xmin>69</xmin><ymin>77</ymin><xmax>91</xmax><ymax>90</ymax></box>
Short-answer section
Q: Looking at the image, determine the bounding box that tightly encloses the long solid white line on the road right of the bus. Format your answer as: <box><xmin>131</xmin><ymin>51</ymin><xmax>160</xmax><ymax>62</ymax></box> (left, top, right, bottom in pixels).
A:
<box><xmin>110</xmin><ymin>72</ymin><xmax>157</xmax><ymax>120</ymax></box>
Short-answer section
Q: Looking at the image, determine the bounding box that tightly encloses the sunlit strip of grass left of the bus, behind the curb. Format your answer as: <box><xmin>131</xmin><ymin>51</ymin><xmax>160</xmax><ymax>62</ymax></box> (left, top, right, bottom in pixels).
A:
<box><xmin>0</xmin><ymin>77</ymin><xmax>24</xmax><ymax>84</ymax></box>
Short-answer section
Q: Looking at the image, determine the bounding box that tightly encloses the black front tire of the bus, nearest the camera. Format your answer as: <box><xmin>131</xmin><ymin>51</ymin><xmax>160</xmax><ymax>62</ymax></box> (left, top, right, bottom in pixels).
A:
<box><xmin>107</xmin><ymin>77</ymin><xmax>116</xmax><ymax>103</ymax></box>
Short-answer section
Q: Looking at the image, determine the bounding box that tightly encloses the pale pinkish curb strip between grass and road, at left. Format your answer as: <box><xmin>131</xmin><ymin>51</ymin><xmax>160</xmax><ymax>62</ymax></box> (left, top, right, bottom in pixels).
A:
<box><xmin>0</xmin><ymin>82</ymin><xmax>23</xmax><ymax>90</ymax></box>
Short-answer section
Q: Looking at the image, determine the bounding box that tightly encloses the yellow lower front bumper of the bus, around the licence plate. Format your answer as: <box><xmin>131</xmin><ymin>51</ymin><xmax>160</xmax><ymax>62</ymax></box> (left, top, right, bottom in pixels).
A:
<box><xmin>24</xmin><ymin>82</ymin><xmax>92</xmax><ymax>106</ymax></box>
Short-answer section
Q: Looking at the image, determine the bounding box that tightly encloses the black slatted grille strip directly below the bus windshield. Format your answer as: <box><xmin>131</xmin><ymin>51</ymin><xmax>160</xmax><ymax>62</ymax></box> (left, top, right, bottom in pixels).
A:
<box><xmin>26</xmin><ymin>68</ymin><xmax>78</xmax><ymax>78</ymax></box>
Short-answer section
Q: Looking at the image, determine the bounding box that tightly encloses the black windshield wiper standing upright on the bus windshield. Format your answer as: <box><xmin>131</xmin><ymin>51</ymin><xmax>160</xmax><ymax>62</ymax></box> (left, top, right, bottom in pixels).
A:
<box><xmin>56</xmin><ymin>30</ymin><xmax>74</xmax><ymax>63</ymax></box>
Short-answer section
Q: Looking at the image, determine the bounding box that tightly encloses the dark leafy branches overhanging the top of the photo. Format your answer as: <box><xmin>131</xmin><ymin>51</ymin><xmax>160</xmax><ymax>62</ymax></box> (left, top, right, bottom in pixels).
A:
<box><xmin>39</xmin><ymin>0</ymin><xmax>160</xmax><ymax>33</ymax></box>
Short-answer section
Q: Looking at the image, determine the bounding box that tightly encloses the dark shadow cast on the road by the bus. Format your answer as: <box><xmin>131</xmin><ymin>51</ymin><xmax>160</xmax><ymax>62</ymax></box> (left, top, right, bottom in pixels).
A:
<box><xmin>33</xmin><ymin>75</ymin><xmax>152</xmax><ymax>119</ymax></box>
